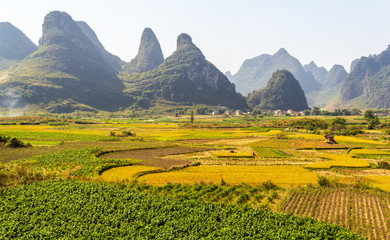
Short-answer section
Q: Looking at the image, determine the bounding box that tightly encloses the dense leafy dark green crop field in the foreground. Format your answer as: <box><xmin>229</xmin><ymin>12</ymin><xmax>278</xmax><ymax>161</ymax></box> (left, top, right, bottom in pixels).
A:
<box><xmin>0</xmin><ymin>180</ymin><xmax>363</xmax><ymax>239</ymax></box>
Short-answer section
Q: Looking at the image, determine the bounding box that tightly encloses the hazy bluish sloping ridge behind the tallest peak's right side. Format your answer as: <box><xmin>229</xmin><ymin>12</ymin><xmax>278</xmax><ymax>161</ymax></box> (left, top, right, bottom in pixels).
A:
<box><xmin>76</xmin><ymin>21</ymin><xmax>124</xmax><ymax>72</ymax></box>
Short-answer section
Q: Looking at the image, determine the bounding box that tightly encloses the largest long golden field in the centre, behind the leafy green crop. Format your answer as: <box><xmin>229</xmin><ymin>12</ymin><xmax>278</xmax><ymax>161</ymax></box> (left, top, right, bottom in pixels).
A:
<box><xmin>139</xmin><ymin>165</ymin><xmax>317</xmax><ymax>187</ymax></box>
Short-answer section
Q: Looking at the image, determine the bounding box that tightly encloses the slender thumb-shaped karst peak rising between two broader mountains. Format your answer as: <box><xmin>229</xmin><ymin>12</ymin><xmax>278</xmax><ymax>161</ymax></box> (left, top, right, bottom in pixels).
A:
<box><xmin>124</xmin><ymin>28</ymin><xmax>164</xmax><ymax>73</ymax></box>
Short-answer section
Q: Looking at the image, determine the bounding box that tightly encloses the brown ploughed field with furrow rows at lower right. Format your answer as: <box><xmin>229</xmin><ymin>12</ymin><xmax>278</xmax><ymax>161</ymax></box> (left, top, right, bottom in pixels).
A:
<box><xmin>280</xmin><ymin>188</ymin><xmax>390</xmax><ymax>240</ymax></box>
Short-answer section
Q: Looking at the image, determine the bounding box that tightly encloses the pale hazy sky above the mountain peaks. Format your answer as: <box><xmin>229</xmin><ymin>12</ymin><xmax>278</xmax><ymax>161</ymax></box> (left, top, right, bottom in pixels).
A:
<box><xmin>0</xmin><ymin>0</ymin><xmax>390</xmax><ymax>74</ymax></box>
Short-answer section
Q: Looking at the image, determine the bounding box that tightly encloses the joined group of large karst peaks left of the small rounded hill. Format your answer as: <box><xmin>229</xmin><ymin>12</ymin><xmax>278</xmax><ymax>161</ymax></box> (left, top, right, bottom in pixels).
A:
<box><xmin>0</xmin><ymin>11</ymin><xmax>248</xmax><ymax>112</ymax></box>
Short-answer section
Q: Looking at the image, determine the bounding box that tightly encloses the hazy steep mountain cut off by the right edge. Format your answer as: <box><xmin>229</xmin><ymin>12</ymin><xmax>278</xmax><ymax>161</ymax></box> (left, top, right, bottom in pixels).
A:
<box><xmin>340</xmin><ymin>46</ymin><xmax>390</xmax><ymax>108</ymax></box>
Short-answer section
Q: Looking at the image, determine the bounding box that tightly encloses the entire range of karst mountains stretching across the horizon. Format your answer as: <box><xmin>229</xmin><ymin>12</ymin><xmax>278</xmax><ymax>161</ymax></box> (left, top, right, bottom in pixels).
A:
<box><xmin>0</xmin><ymin>11</ymin><xmax>390</xmax><ymax>112</ymax></box>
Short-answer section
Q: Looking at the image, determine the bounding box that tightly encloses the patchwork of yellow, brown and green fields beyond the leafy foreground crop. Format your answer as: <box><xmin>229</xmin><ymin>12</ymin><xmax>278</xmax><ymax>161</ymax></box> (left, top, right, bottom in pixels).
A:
<box><xmin>0</xmin><ymin>115</ymin><xmax>390</xmax><ymax>239</ymax></box>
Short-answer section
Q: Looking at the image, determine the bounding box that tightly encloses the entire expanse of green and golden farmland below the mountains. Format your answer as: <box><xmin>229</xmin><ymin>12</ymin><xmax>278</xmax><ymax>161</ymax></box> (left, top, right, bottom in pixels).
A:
<box><xmin>0</xmin><ymin>116</ymin><xmax>390</xmax><ymax>239</ymax></box>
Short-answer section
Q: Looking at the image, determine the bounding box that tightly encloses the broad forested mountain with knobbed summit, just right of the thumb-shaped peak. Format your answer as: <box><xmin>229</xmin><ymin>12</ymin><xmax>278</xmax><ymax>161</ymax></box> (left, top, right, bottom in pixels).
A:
<box><xmin>125</xmin><ymin>33</ymin><xmax>247</xmax><ymax>109</ymax></box>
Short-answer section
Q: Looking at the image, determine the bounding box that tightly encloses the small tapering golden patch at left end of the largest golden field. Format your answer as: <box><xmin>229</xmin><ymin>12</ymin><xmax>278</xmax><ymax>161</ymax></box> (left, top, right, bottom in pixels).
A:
<box><xmin>100</xmin><ymin>166</ymin><xmax>162</xmax><ymax>182</ymax></box>
